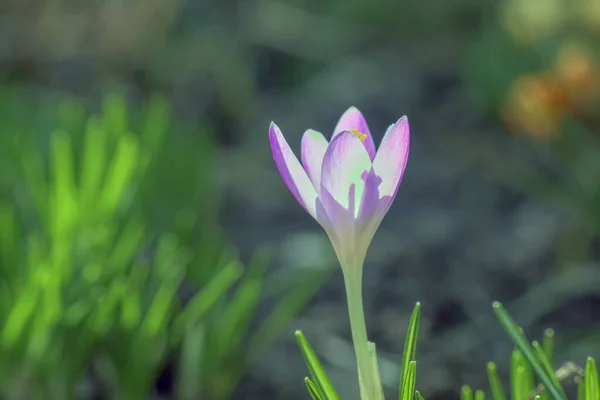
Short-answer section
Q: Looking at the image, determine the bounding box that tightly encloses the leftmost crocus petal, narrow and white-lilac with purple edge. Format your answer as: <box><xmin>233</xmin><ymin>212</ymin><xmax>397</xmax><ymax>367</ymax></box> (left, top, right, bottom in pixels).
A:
<box><xmin>269</xmin><ymin>122</ymin><xmax>317</xmax><ymax>219</ymax></box>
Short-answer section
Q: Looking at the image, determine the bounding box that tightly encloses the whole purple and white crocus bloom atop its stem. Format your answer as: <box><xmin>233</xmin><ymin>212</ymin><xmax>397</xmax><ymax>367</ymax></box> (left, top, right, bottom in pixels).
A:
<box><xmin>269</xmin><ymin>107</ymin><xmax>410</xmax><ymax>269</ymax></box>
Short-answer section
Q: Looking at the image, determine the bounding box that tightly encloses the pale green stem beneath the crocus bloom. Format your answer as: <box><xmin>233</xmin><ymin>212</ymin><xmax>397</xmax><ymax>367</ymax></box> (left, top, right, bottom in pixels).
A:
<box><xmin>344</xmin><ymin>265</ymin><xmax>378</xmax><ymax>400</ymax></box>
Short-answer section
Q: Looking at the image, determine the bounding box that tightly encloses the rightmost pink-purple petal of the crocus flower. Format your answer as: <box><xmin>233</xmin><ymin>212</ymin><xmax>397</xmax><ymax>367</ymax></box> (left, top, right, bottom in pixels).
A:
<box><xmin>373</xmin><ymin>116</ymin><xmax>410</xmax><ymax>204</ymax></box>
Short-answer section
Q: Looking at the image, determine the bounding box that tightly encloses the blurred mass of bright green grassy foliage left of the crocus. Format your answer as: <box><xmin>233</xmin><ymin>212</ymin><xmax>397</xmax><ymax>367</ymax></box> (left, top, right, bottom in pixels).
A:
<box><xmin>0</xmin><ymin>88</ymin><xmax>323</xmax><ymax>400</ymax></box>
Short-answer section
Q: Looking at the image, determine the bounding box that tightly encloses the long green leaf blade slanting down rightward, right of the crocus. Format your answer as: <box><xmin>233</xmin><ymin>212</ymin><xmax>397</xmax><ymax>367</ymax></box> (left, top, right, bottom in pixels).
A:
<box><xmin>493</xmin><ymin>302</ymin><xmax>567</xmax><ymax>400</ymax></box>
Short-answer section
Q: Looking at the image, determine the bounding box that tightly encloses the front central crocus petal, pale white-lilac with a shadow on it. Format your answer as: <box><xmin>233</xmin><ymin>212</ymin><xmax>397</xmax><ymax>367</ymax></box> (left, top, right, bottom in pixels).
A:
<box><xmin>321</xmin><ymin>131</ymin><xmax>371</xmax><ymax>211</ymax></box>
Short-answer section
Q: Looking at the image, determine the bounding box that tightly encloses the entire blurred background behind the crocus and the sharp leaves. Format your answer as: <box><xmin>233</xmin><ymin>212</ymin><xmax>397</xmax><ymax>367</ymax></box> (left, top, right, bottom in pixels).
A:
<box><xmin>0</xmin><ymin>0</ymin><xmax>600</xmax><ymax>400</ymax></box>
